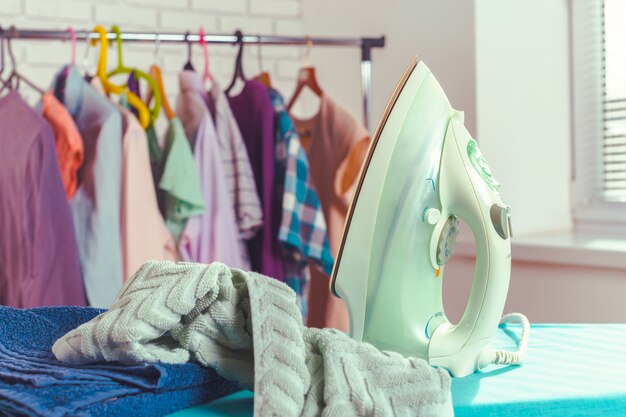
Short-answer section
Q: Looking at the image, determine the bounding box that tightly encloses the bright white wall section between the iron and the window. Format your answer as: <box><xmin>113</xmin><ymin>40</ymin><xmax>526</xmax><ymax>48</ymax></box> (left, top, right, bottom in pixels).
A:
<box><xmin>475</xmin><ymin>0</ymin><xmax>572</xmax><ymax>235</ymax></box>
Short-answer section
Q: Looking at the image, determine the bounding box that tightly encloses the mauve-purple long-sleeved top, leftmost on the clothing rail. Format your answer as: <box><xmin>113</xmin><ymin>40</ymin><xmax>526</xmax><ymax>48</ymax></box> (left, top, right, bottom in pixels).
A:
<box><xmin>0</xmin><ymin>92</ymin><xmax>86</xmax><ymax>307</ymax></box>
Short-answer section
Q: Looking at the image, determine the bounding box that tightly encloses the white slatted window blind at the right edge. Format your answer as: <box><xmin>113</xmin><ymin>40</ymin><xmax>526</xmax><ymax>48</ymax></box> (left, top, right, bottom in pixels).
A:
<box><xmin>602</xmin><ymin>0</ymin><xmax>626</xmax><ymax>202</ymax></box>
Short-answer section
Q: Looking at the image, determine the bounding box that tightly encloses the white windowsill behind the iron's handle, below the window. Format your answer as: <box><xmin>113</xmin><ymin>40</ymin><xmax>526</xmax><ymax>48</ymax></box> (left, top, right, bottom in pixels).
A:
<box><xmin>455</xmin><ymin>232</ymin><xmax>626</xmax><ymax>269</ymax></box>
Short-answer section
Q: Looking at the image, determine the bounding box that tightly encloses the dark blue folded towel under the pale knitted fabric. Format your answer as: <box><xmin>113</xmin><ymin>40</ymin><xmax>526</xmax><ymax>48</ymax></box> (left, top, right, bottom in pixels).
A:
<box><xmin>0</xmin><ymin>306</ymin><xmax>239</xmax><ymax>417</ymax></box>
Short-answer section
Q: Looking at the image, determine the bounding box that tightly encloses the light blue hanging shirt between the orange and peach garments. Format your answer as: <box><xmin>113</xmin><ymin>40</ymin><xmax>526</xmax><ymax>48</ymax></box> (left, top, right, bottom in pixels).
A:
<box><xmin>53</xmin><ymin>66</ymin><xmax>123</xmax><ymax>307</ymax></box>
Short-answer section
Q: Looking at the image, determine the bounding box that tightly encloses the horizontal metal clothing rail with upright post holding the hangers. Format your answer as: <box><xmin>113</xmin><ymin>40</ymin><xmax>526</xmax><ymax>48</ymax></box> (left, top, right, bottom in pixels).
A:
<box><xmin>0</xmin><ymin>27</ymin><xmax>385</xmax><ymax>129</ymax></box>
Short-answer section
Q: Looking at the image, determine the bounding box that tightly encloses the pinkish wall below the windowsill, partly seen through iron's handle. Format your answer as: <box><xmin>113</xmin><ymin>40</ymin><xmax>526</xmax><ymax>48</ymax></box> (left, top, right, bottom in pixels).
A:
<box><xmin>444</xmin><ymin>255</ymin><xmax>626</xmax><ymax>323</ymax></box>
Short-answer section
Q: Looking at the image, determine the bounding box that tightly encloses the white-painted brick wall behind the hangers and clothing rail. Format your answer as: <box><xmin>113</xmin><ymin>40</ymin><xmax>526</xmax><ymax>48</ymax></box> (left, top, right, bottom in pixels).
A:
<box><xmin>0</xmin><ymin>0</ymin><xmax>304</xmax><ymax>102</ymax></box>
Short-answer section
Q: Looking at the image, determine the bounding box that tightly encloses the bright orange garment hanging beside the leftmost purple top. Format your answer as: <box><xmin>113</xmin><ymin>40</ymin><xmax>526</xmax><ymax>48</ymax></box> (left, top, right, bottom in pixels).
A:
<box><xmin>41</xmin><ymin>91</ymin><xmax>83</xmax><ymax>199</ymax></box>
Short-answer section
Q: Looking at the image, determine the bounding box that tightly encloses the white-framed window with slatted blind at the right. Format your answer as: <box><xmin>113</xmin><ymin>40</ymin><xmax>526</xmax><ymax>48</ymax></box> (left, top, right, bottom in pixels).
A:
<box><xmin>570</xmin><ymin>0</ymin><xmax>626</xmax><ymax>234</ymax></box>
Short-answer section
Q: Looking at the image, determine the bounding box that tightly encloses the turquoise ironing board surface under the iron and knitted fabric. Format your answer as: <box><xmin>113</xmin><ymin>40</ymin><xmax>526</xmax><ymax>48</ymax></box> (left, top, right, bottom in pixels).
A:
<box><xmin>165</xmin><ymin>324</ymin><xmax>626</xmax><ymax>417</ymax></box>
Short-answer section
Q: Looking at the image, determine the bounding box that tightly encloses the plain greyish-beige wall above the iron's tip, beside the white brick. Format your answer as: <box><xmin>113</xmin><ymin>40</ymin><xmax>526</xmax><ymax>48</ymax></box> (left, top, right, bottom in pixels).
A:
<box><xmin>302</xmin><ymin>0</ymin><xmax>476</xmax><ymax>134</ymax></box>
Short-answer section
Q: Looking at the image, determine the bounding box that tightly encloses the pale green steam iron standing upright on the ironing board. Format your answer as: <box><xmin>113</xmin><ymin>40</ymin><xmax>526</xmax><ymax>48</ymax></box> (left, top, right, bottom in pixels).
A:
<box><xmin>331</xmin><ymin>58</ymin><xmax>528</xmax><ymax>377</ymax></box>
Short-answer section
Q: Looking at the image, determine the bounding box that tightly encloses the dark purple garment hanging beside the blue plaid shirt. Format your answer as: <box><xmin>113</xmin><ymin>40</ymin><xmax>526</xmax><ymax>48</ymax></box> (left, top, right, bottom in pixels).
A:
<box><xmin>229</xmin><ymin>80</ymin><xmax>284</xmax><ymax>281</ymax></box>
